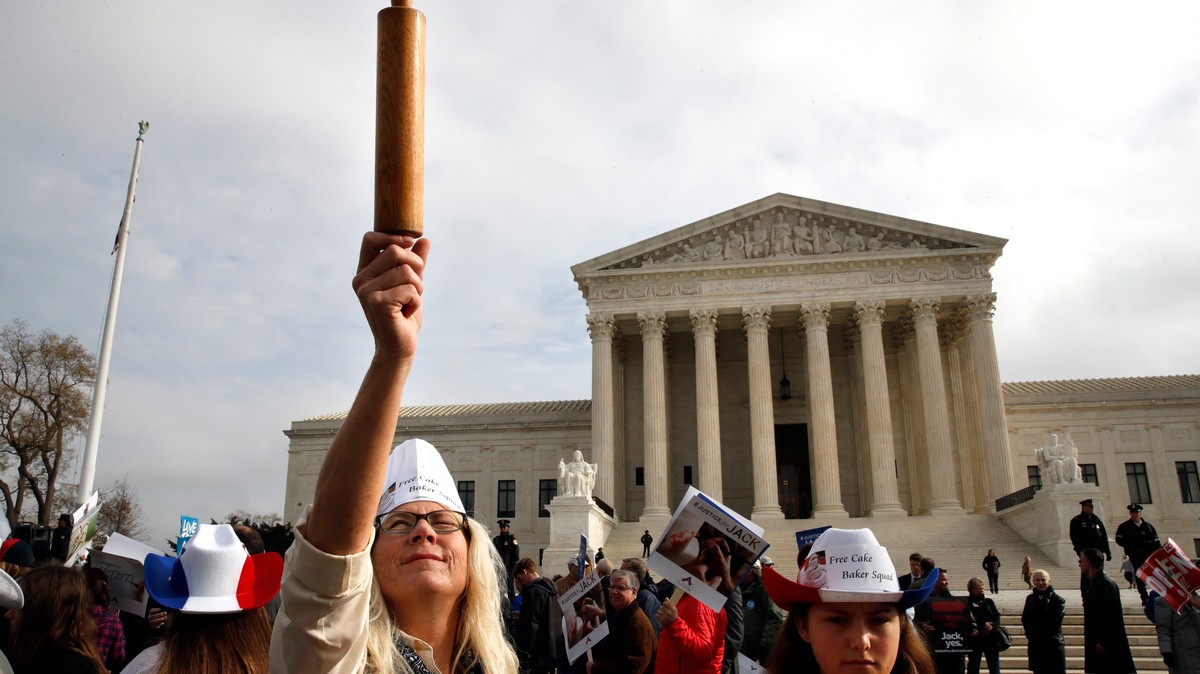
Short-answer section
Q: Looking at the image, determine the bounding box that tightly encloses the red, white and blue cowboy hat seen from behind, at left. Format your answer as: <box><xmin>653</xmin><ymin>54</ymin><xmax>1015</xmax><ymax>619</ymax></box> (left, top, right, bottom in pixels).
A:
<box><xmin>145</xmin><ymin>524</ymin><xmax>283</xmax><ymax>613</ymax></box>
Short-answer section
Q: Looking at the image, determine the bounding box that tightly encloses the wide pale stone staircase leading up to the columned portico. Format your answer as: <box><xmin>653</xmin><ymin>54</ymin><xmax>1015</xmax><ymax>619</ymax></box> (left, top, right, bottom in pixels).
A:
<box><xmin>604</xmin><ymin>514</ymin><xmax>1166</xmax><ymax>673</ymax></box>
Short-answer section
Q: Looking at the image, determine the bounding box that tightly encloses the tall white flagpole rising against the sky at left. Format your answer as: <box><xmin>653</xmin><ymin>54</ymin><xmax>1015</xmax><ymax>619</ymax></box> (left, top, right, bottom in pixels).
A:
<box><xmin>76</xmin><ymin>121</ymin><xmax>150</xmax><ymax>504</ymax></box>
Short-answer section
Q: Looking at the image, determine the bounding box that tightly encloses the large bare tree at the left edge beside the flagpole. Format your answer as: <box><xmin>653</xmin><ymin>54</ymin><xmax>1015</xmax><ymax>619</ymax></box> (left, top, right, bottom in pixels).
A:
<box><xmin>0</xmin><ymin>320</ymin><xmax>96</xmax><ymax>525</ymax></box>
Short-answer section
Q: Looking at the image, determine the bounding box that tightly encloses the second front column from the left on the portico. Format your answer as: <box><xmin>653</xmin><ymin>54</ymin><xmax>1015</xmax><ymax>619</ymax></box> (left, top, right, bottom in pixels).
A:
<box><xmin>637</xmin><ymin>313</ymin><xmax>671</xmax><ymax>517</ymax></box>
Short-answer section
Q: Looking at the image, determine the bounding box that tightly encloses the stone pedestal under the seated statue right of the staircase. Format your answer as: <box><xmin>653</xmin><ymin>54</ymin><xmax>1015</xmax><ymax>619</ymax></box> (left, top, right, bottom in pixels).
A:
<box><xmin>996</xmin><ymin>482</ymin><xmax>1108</xmax><ymax>568</ymax></box>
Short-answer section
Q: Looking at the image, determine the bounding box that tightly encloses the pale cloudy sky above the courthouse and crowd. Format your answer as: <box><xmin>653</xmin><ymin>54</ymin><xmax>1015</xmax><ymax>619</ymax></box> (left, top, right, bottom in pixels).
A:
<box><xmin>0</xmin><ymin>0</ymin><xmax>1200</xmax><ymax>546</ymax></box>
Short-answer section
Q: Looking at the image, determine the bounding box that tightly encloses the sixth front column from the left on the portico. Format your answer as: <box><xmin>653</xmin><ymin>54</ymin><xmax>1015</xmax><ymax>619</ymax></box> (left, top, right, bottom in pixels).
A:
<box><xmin>854</xmin><ymin>300</ymin><xmax>905</xmax><ymax>516</ymax></box>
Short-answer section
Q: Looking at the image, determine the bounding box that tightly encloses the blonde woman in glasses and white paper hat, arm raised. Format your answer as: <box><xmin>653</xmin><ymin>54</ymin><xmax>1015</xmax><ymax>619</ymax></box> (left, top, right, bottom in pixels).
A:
<box><xmin>271</xmin><ymin>233</ymin><xmax>517</xmax><ymax>674</ymax></box>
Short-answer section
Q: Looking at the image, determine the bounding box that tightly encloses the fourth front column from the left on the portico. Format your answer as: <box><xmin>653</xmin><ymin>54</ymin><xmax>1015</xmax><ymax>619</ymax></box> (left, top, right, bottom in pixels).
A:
<box><xmin>742</xmin><ymin>307</ymin><xmax>784</xmax><ymax>520</ymax></box>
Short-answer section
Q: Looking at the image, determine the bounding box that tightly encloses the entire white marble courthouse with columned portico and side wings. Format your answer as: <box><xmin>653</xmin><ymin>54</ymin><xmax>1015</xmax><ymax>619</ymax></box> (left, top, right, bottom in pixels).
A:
<box><xmin>284</xmin><ymin>194</ymin><xmax>1200</xmax><ymax>547</ymax></box>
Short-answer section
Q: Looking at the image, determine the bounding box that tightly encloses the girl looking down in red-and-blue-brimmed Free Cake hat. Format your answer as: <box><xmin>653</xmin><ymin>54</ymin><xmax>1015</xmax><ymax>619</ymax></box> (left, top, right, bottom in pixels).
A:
<box><xmin>763</xmin><ymin>529</ymin><xmax>936</xmax><ymax>674</ymax></box>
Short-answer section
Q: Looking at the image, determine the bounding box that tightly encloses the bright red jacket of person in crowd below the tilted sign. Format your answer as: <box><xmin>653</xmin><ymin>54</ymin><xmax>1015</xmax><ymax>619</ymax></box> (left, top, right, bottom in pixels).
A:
<box><xmin>654</xmin><ymin>595</ymin><xmax>727</xmax><ymax>674</ymax></box>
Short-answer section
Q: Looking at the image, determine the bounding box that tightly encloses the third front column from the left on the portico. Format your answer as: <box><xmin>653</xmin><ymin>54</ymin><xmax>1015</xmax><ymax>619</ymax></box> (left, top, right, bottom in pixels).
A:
<box><xmin>688</xmin><ymin>309</ymin><xmax>721</xmax><ymax>500</ymax></box>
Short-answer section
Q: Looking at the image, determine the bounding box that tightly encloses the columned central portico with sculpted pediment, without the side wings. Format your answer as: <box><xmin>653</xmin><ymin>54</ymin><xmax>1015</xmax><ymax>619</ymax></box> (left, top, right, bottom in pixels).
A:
<box><xmin>572</xmin><ymin>194</ymin><xmax>1013</xmax><ymax>519</ymax></box>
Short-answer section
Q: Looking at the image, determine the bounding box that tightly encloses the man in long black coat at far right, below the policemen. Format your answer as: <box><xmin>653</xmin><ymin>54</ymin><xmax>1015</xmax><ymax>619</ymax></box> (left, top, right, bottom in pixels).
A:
<box><xmin>1079</xmin><ymin>548</ymin><xmax>1138</xmax><ymax>674</ymax></box>
